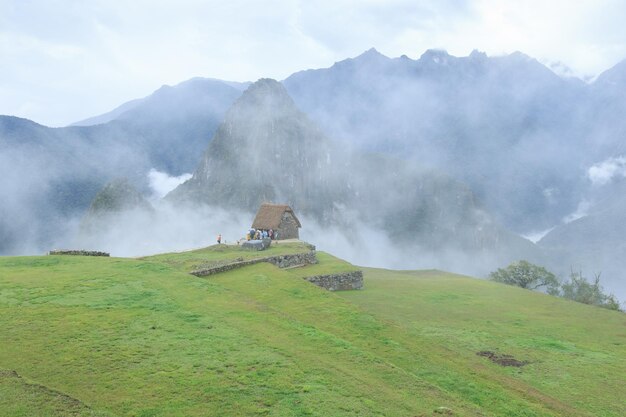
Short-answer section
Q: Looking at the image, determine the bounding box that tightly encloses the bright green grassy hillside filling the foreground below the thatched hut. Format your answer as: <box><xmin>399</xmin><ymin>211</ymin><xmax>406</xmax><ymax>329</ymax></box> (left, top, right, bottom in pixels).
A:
<box><xmin>0</xmin><ymin>245</ymin><xmax>626</xmax><ymax>416</ymax></box>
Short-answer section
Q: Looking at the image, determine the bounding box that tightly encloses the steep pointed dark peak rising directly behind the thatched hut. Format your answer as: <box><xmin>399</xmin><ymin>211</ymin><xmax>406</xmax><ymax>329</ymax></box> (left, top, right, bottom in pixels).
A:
<box><xmin>168</xmin><ymin>79</ymin><xmax>347</xmax><ymax>216</ymax></box>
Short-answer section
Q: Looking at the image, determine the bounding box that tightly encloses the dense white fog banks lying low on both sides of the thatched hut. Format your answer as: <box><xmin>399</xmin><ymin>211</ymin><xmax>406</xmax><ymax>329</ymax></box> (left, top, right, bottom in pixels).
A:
<box><xmin>62</xmin><ymin>193</ymin><xmax>510</xmax><ymax>282</ymax></box>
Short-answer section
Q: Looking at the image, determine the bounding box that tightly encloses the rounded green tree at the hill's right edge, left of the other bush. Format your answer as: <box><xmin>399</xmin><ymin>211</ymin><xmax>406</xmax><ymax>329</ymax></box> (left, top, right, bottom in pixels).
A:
<box><xmin>489</xmin><ymin>260</ymin><xmax>559</xmax><ymax>294</ymax></box>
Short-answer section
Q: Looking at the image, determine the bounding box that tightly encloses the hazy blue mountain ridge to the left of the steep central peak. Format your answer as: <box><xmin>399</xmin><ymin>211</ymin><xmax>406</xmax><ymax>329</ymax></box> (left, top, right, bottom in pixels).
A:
<box><xmin>0</xmin><ymin>79</ymin><xmax>241</xmax><ymax>254</ymax></box>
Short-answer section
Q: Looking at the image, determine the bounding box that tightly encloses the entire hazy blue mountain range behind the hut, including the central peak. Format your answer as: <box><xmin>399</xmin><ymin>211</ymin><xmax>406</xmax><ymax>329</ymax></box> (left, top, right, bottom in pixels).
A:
<box><xmin>7</xmin><ymin>49</ymin><xmax>626</xmax><ymax>290</ymax></box>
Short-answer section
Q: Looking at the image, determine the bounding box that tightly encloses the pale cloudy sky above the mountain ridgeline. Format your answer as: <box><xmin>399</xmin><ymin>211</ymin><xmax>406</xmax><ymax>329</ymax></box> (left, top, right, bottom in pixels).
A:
<box><xmin>0</xmin><ymin>0</ymin><xmax>626</xmax><ymax>126</ymax></box>
